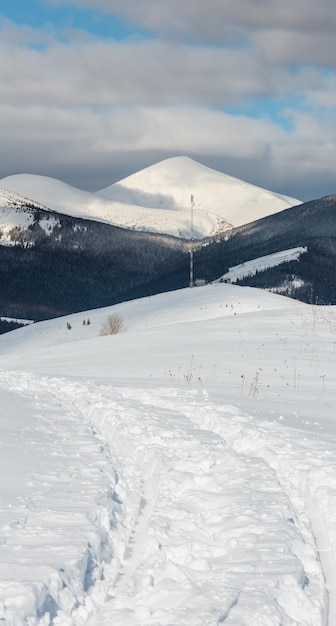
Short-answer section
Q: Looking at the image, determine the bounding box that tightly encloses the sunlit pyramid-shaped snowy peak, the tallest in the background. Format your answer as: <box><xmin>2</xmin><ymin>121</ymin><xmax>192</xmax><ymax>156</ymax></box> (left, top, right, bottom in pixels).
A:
<box><xmin>97</xmin><ymin>156</ymin><xmax>301</xmax><ymax>230</ymax></box>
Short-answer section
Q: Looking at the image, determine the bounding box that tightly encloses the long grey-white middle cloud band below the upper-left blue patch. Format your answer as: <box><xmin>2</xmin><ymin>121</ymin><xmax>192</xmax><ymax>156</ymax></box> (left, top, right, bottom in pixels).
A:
<box><xmin>0</xmin><ymin>32</ymin><xmax>330</xmax><ymax>107</ymax></box>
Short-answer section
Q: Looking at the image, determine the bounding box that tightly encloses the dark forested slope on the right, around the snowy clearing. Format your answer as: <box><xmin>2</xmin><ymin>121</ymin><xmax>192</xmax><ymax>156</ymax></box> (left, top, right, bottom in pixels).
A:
<box><xmin>195</xmin><ymin>195</ymin><xmax>336</xmax><ymax>304</ymax></box>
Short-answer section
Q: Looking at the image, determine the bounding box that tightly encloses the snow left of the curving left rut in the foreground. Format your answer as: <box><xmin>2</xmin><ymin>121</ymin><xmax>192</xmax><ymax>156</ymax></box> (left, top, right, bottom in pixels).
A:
<box><xmin>0</xmin><ymin>374</ymin><xmax>126</xmax><ymax>626</ymax></box>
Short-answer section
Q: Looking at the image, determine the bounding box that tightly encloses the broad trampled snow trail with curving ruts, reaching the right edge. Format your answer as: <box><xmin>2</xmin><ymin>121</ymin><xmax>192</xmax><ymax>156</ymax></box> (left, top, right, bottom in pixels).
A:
<box><xmin>0</xmin><ymin>374</ymin><xmax>336</xmax><ymax>626</ymax></box>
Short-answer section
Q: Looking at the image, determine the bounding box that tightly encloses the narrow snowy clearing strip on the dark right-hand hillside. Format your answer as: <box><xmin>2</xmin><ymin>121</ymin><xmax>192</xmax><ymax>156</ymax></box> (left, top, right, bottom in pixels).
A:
<box><xmin>219</xmin><ymin>246</ymin><xmax>307</xmax><ymax>283</ymax></box>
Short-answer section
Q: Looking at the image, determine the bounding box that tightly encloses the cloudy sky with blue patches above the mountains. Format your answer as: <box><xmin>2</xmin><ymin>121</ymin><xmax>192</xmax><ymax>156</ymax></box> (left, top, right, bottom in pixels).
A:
<box><xmin>0</xmin><ymin>0</ymin><xmax>336</xmax><ymax>200</ymax></box>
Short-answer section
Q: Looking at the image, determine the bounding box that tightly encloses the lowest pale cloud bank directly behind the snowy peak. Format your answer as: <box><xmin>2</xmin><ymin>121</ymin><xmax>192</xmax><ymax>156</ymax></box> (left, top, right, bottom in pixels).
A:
<box><xmin>0</xmin><ymin>96</ymin><xmax>336</xmax><ymax>198</ymax></box>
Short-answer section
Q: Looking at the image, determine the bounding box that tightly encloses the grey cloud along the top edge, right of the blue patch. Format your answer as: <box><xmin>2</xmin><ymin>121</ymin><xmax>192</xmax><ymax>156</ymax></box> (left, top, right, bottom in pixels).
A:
<box><xmin>49</xmin><ymin>0</ymin><xmax>336</xmax><ymax>43</ymax></box>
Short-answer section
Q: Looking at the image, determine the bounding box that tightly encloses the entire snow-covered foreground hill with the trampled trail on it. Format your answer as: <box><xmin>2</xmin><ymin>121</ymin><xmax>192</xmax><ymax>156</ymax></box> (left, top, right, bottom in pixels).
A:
<box><xmin>0</xmin><ymin>283</ymin><xmax>336</xmax><ymax>626</ymax></box>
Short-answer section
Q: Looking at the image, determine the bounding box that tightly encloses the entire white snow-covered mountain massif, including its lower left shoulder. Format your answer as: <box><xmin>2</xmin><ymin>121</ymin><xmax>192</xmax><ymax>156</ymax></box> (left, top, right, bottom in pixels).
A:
<box><xmin>0</xmin><ymin>157</ymin><xmax>301</xmax><ymax>239</ymax></box>
